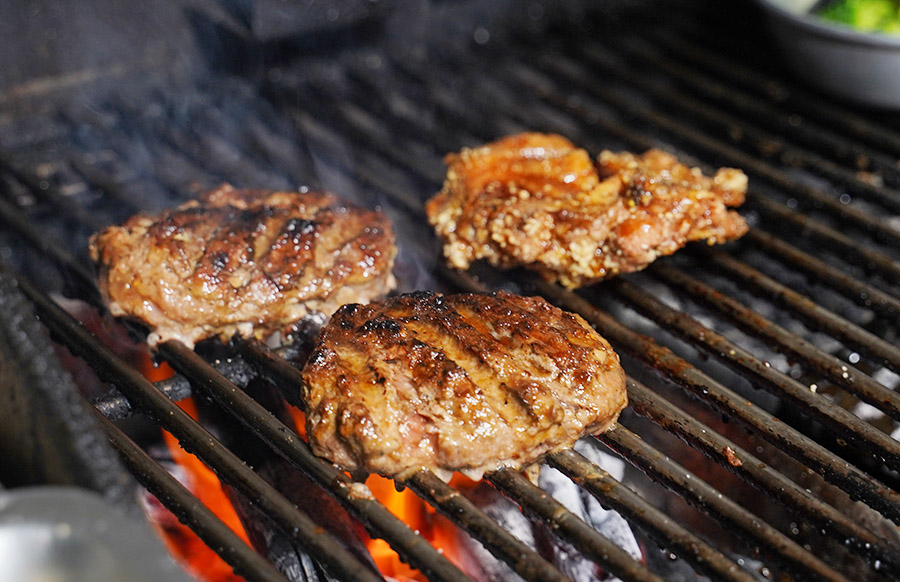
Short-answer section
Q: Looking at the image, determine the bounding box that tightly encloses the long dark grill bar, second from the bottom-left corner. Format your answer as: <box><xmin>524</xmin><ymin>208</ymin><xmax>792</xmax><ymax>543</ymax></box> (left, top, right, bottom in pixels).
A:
<box><xmin>11</xmin><ymin>280</ymin><xmax>381</xmax><ymax>582</ymax></box>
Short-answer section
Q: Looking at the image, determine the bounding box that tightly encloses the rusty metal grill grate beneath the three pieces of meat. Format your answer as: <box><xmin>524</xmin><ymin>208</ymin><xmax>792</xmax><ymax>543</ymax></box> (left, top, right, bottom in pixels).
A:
<box><xmin>0</xmin><ymin>3</ymin><xmax>900</xmax><ymax>581</ymax></box>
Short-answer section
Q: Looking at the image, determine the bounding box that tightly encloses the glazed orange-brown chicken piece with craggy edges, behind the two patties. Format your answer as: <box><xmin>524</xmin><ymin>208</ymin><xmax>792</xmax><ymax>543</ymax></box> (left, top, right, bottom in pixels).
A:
<box><xmin>426</xmin><ymin>133</ymin><xmax>747</xmax><ymax>288</ymax></box>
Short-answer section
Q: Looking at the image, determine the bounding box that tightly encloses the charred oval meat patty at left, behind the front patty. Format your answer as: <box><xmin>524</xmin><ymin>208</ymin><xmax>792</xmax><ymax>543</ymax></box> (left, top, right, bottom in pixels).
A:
<box><xmin>90</xmin><ymin>185</ymin><xmax>396</xmax><ymax>346</ymax></box>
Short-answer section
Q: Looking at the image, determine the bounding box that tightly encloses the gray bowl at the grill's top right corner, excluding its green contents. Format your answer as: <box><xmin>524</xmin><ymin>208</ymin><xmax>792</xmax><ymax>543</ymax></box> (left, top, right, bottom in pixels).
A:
<box><xmin>757</xmin><ymin>0</ymin><xmax>900</xmax><ymax>109</ymax></box>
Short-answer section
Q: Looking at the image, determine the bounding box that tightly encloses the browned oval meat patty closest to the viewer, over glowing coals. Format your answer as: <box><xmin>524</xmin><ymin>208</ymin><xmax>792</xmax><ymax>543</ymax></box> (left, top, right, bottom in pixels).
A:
<box><xmin>303</xmin><ymin>292</ymin><xmax>626</xmax><ymax>479</ymax></box>
